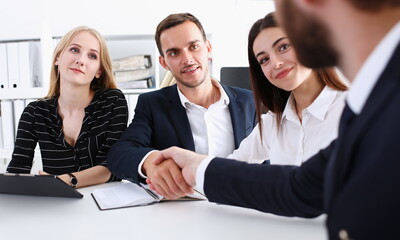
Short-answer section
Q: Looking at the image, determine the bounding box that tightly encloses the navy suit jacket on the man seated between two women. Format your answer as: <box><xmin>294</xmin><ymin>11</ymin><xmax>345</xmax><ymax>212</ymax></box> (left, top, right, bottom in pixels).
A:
<box><xmin>107</xmin><ymin>85</ymin><xmax>256</xmax><ymax>183</ymax></box>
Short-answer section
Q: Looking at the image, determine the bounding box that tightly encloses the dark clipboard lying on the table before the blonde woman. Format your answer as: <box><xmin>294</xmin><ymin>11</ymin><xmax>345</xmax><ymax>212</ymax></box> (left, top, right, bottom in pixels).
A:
<box><xmin>0</xmin><ymin>173</ymin><xmax>83</xmax><ymax>198</ymax></box>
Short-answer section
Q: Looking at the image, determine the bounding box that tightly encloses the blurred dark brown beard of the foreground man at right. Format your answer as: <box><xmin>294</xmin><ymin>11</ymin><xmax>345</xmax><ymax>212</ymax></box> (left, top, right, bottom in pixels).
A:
<box><xmin>277</xmin><ymin>0</ymin><xmax>338</xmax><ymax>68</ymax></box>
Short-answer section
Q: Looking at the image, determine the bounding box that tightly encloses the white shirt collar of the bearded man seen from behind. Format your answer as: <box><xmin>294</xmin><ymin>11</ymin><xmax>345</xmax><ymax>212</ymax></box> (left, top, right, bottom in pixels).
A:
<box><xmin>347</xmin><ymin>21</ymin><xmax>400</xmax><ymax>114</ymax></box>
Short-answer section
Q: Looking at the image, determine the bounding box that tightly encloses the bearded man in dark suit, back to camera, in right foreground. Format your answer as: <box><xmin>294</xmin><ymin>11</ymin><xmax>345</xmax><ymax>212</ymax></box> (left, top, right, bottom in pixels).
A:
<box><xmin>153</xmin><ymin>0</ymin><xmax>400</xmax><ymax>239</ymax></box>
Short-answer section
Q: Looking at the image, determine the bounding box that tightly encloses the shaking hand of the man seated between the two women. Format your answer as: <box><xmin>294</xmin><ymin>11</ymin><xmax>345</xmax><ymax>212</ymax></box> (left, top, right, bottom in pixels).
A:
<box><xmin>142</xmin><ymin>152</ymin><xmax>193</xmax><ymax>199</ymax></box>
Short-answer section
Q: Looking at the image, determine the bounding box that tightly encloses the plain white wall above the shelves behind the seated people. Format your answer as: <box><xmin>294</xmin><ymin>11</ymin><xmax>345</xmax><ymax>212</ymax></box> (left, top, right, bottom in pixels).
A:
<box><xmin>0</xmin><ymin>0</ymin><xmax>274</xmax><ymax>78</ymax></box>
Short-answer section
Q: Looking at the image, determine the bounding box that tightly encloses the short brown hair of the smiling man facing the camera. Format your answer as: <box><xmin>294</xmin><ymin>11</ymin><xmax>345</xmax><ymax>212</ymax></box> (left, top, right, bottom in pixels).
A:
<box><xmin>155</xmin><ymin>13</ymin><xmax>207</xmax><ymax>57</ymax></box>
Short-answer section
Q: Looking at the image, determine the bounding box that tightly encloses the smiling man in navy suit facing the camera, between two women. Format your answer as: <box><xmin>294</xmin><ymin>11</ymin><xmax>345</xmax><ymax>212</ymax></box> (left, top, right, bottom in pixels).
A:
<box><xmin>108</xmin><ymin>13</ymin><xmax>256</xmax><ymax>199</ymax></box>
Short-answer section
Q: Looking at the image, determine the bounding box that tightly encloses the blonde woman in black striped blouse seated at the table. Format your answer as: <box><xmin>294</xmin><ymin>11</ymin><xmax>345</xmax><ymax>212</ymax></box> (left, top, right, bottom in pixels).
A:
<box><xmin>7</xmin><ymin>26</ymin><xmax>128</xmax><ymax>188</ymax></box>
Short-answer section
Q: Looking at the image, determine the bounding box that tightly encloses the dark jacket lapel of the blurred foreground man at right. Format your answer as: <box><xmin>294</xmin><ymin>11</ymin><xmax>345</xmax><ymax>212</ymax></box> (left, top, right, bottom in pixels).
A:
<box><xmin>325</xmin><ymin>42</ymin><xmax>400</xmax><ymax>209</ymax></box>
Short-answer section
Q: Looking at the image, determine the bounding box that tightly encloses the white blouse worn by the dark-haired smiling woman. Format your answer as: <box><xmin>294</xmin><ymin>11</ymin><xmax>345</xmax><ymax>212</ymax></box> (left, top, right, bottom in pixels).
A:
<box><xmin>228</xmin><ymin>86</ymin><xmax>346</xmax><ymax>166</ymax></box>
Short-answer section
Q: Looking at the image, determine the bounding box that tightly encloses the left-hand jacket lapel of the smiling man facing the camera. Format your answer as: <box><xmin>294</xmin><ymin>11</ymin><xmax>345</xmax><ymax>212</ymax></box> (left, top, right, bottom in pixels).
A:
<box><xmin>165</xmin><ymin>84</ymin><xmax>195</xmax><ymax>151</ymax></box>
